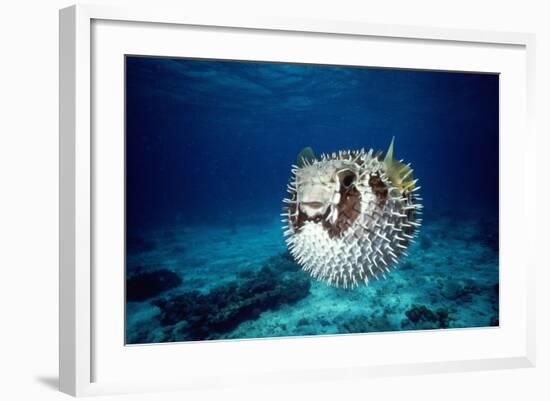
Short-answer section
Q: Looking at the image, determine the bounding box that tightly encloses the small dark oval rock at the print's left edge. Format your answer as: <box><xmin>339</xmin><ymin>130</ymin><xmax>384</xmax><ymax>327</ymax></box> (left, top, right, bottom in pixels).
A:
<box><xmin>126</xmin><ymin>269</ymin><xmax>182</xmax><ymax>302</ymax></box>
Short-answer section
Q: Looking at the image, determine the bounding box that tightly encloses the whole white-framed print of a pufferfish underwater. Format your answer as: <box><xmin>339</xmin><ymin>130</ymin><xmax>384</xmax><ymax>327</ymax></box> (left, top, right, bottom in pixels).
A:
<box><xmin>60</xmin><ymin>6</ymin><xmax>534</xmax><ymax>395</ymax></box>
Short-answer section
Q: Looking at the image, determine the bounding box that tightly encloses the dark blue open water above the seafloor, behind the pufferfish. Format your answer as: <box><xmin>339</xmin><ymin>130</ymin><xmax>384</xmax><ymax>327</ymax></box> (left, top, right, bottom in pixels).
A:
<box><xmin>126</xmin><ymin>56</ymin><xmax>498</xmax><ymax>231</ymax></box>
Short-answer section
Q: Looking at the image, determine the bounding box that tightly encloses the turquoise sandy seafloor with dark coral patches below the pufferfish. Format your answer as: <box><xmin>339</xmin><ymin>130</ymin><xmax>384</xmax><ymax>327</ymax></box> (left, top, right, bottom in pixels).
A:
<box><xmin>126</xmin><ymin>214</ymin><xmax>498</xmax><ymax>344</ymax></box>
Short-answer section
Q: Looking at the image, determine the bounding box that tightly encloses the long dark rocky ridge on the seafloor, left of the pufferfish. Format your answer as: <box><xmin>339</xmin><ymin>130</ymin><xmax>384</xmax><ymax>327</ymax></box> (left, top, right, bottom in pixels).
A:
<box><xmin>153</xmin><ymin>252</ymin><xmax>311</xmax><ymax>341</ymax></box>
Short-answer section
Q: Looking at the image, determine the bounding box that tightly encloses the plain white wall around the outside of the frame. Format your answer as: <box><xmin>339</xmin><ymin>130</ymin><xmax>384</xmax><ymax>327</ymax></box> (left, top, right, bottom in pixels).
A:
<box><xmin>0</xmin><ymin>0</ymin><xmax>550</xmax><ymax>400</ymax></box>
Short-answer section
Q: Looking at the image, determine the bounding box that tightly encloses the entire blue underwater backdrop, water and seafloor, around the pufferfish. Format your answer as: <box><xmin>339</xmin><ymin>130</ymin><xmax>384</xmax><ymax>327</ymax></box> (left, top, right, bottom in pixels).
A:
<box><xmin>126</xmin><ymin>56</ymin><xmax>499</xmax><ymax>343</ymax></box>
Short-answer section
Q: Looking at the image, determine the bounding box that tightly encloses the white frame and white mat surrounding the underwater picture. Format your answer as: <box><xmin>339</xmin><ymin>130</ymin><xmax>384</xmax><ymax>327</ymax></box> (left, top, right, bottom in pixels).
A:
<box><xmin>59</xmin><ymin>5</ymin><xmax>536</xmax><ymax>396</ymax></box>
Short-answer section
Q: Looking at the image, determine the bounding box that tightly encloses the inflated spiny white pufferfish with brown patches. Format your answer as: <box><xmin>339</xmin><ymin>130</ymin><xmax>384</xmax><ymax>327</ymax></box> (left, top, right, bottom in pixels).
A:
<box><xmin>282</xmin><ymin>139</ymin><xmax>422</xmax><ymax>288</ymax></box>
